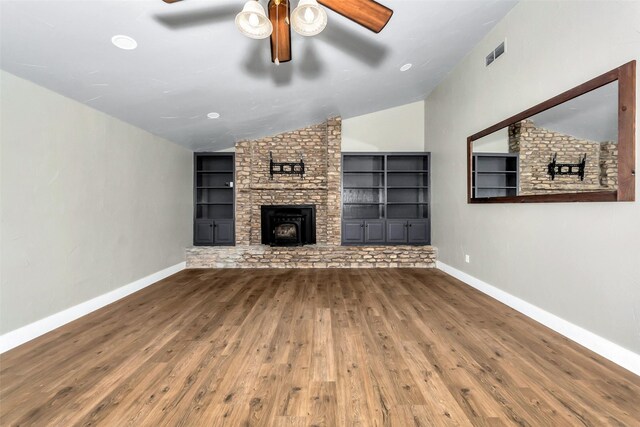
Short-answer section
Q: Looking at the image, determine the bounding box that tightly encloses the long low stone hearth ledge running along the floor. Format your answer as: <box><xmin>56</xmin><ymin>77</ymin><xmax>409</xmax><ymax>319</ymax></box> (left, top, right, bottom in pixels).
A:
<box><xmin>186</xmin><ymin>245</ymin><xmax>438</xmax><ymax>268</ymax></box>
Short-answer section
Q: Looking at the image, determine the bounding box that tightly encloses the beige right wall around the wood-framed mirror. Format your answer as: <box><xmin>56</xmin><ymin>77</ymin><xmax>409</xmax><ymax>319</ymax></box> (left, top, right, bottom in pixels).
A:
<box><xmin>425</xmin><ymin>0</ymin><xmax>640</xmax><ymax>353</ymax></box>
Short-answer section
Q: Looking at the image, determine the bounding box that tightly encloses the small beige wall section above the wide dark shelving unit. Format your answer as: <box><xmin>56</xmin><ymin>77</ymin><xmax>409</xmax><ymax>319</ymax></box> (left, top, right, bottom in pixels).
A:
<box><xmin>342</xmin><ymin>101</ymin><xmax>424</xmax><ymax>151</ymax></box>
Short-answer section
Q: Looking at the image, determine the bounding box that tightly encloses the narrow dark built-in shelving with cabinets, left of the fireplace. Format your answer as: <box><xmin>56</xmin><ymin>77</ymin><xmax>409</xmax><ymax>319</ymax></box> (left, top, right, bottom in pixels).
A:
<box><xmin>193</xmin><ymin>153</ymin><xmax>235</xmax><ymax>246</ymax></box>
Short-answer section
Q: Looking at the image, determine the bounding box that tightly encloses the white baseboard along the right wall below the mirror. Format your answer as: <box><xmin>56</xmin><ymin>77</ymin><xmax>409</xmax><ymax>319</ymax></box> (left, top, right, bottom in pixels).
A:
<box><xmin>436</xmin><ymin>261</ymin><xmax>640</xmax><ymax>375</ymax></box>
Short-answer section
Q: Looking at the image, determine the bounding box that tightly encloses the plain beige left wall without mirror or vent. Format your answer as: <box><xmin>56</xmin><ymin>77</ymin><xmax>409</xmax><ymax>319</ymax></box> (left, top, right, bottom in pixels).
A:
<box><xmin>0</xmin><ymin>71</ymin><xmax>193</xmax><ymax>333</ymax></box>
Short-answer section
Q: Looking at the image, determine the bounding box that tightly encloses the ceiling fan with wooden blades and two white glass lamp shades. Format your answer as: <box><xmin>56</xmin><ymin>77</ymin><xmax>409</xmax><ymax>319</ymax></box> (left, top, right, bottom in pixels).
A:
<box><xmin>163</xmin><ymin>0</ymin><xmax>393</xmax><ymax>65</ymax></box>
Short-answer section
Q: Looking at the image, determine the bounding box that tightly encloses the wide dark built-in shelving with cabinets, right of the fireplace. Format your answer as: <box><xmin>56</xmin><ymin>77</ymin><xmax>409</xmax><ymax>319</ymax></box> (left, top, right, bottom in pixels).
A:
<box><xmin>342</xmin><ymin>153</ymin><xmax>431</xmax><ymax>245</ymax></box>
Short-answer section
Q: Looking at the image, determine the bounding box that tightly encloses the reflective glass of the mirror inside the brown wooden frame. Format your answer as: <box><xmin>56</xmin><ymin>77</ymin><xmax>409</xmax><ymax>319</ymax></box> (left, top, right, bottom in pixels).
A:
<box><xmin>473</xmin><ymin>82</ymin><xmax>618</xmax><ymax>197</ymax></box>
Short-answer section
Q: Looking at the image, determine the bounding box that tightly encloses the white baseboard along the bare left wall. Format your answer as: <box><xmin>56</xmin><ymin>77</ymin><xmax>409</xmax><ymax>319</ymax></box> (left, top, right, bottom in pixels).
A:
<box><xmin>0</xmin><ymin>262</ymin><xmax>186</xmax><ymax>353</ymax></box>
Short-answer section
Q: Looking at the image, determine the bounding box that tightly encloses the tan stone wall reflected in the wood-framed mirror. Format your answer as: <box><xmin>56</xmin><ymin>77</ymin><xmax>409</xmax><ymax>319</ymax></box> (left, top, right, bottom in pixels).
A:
<box><xmin>509</xmin><ymin>120</ymin><xmax>618</xmax><ymax>196</ymax></box>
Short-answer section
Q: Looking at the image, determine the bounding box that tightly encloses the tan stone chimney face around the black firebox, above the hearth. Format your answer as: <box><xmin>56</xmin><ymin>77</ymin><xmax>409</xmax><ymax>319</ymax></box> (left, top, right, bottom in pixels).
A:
<box><xmin>236</xmin><ymin>118</ymin><xmax>342</xmax><ymax>245</ymax></box>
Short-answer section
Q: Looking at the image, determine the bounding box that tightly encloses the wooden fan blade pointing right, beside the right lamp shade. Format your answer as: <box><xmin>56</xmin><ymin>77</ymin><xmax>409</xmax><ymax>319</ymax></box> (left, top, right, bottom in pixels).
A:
<box><xmin>318</xmin><ymin>0</ymin><xmax>393</xmax><ymax>33</ymax></box>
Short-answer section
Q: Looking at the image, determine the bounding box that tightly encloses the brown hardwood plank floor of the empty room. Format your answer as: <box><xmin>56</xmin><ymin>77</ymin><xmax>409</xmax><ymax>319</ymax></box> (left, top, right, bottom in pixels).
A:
<box><xmin>0</xmin><ymin>269</ymin><xmax>640</xmax><ymax>426</ymax></box>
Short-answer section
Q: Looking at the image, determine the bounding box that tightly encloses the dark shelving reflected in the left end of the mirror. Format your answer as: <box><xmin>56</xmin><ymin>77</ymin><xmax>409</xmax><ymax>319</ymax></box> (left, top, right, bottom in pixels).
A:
<box><xmin>472</xmin><ymin>153</ymin><xmax>520</xmax><ymax>198</ymax></box>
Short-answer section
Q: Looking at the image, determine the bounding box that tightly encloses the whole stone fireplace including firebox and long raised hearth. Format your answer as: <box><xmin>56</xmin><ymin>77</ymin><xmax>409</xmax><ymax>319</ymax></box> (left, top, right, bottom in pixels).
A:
<box><xmin>186</xmin><ymin>117</ymin><xmax>437</xmax><ymax>268</ymax></box>
